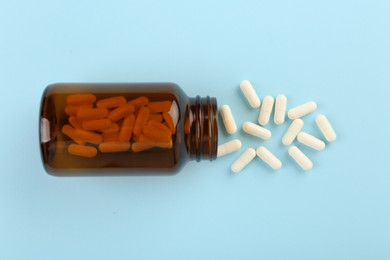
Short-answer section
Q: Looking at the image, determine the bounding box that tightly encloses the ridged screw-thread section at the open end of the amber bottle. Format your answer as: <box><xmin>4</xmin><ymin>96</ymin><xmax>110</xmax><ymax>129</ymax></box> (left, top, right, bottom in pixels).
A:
<box><xmin>195</xmin><ymin>96</ymin><xmax>218</xmax><ymax>162</ymax></box>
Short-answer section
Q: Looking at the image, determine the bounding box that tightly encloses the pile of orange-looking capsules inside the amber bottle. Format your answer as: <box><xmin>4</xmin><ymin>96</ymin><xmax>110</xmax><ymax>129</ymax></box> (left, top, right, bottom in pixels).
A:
<box><xmin>62</xmin><ymin>94</ymin><xmax>176</xmax><ymax>158</ymax></box>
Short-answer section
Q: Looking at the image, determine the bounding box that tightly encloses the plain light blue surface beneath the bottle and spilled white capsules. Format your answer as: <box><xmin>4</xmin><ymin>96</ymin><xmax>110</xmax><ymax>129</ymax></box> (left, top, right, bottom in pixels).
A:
<box><xmin>0</xmin><ymin>0</ymin><xmax>390</xmax><ymax>260</ymax></box>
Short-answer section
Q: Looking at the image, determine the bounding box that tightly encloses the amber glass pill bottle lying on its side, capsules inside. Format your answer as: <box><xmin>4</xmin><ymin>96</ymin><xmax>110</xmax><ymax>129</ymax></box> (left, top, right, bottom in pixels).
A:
<box><xmin>39</xmin><ymin>83</ymin><xmax>218</xmax><ymax>176</ymax></box>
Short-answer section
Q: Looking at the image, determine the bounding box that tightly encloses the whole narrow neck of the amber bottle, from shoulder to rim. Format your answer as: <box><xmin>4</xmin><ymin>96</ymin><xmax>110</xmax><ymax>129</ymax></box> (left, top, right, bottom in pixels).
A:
<box><xmin>185</xmin><ymin>96</ymin><xmax>218</xmax><ymax>162</ymax></box>
